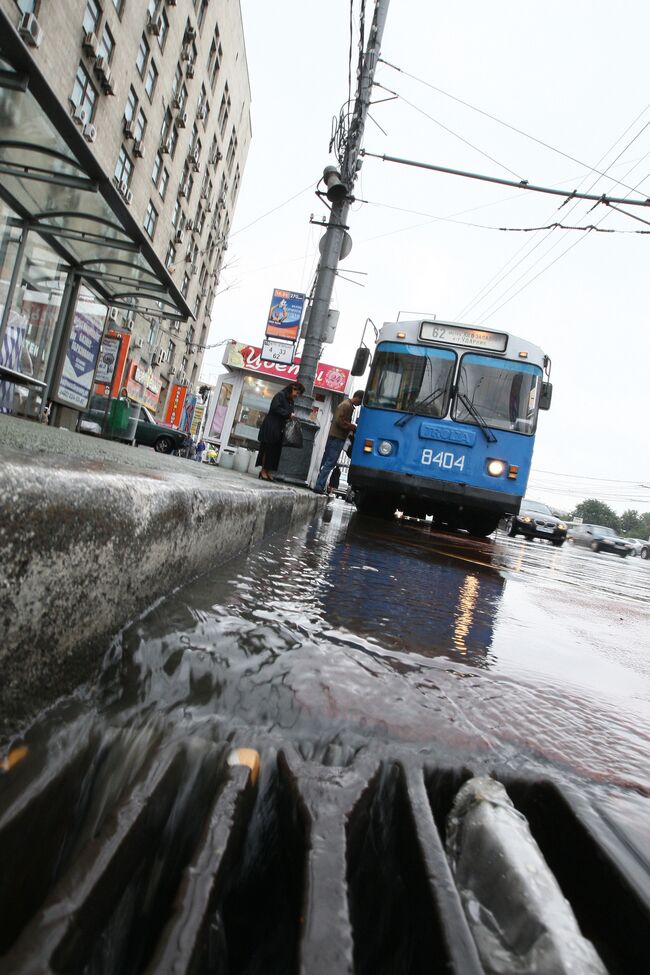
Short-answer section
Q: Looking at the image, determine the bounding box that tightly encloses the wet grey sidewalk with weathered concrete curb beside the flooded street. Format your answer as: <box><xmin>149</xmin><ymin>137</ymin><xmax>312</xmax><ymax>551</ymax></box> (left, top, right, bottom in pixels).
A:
<box><xmin>0</xmin><ymin>415</ymin><xmax>322</xmax><ymax>738</ymax></box>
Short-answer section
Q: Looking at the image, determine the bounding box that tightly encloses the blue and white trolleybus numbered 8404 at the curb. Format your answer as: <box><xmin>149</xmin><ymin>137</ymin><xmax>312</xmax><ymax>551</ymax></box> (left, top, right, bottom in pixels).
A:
<box><xmin>348</xmin><ymin>320</ymin><xmax>552</xmax><ymax>535</ymax></box>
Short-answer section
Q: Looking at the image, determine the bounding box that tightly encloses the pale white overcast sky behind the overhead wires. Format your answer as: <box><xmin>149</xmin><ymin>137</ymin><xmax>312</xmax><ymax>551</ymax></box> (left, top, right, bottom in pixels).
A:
<box><xmin>203</xmin><ymin>0</ymin><xmax>650</xmax><ymax>510</ymax></box>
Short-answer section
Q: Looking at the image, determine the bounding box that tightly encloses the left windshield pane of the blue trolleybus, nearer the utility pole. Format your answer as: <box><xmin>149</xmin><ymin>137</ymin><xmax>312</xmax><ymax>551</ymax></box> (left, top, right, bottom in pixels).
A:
<box><xmin>364</xmin><ymin>342</ymin><xmax>456</xmax><ymax>416</ymax></box>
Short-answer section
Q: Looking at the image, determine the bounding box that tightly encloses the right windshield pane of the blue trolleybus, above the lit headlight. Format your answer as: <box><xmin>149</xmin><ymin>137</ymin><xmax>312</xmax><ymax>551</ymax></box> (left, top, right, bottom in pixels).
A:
<box><xmin>453</xmin><ymin>354</ymin><xmax>542</xmax><ymax>436</ymax></box>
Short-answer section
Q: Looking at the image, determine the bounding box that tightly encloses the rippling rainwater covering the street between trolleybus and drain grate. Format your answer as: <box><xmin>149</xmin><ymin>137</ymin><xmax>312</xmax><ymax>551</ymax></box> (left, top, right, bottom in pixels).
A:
<box><xmin>92</xmin><ymin>502</ymin><xmax>650</xmax><ymax>795</ymax></box>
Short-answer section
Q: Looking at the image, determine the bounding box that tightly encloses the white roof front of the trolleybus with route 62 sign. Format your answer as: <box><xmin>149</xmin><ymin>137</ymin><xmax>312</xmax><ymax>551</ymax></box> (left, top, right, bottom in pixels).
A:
<box><xmin>378</xmin><ymin>318</ymin><xmax>546</xmax><ymax>368</ymax></box>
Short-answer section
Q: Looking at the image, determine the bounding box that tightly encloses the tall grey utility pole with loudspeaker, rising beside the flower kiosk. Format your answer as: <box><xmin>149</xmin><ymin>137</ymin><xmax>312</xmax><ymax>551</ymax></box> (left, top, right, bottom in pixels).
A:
<box><xmin>279</xmin><ymin>0</ymin><xmax>390</xmax><ymax>484</ymax></box>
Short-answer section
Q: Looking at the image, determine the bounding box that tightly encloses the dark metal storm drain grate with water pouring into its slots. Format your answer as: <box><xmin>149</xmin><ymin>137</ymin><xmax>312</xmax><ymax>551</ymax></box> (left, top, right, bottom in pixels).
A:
<box><xmin>0</xmin><ymin>733</ymin><xmax>650</xmax><ymax>975</ymax></box>
